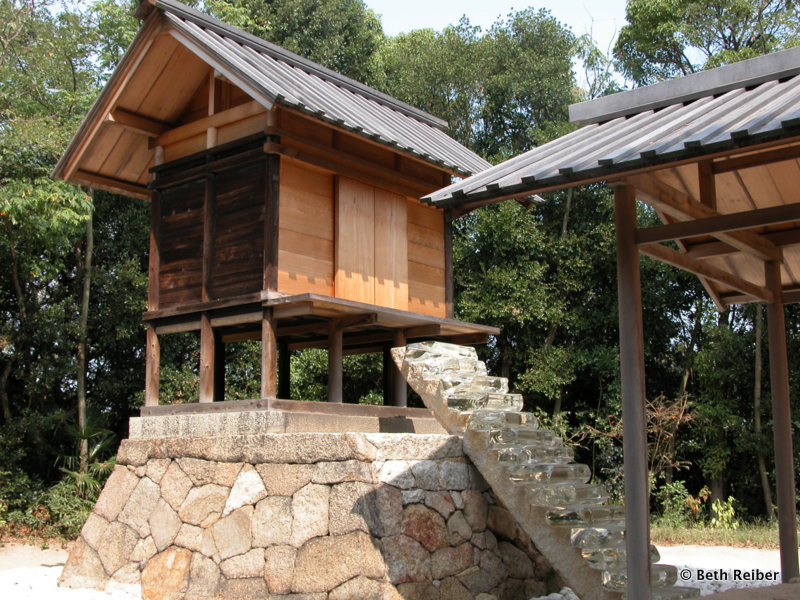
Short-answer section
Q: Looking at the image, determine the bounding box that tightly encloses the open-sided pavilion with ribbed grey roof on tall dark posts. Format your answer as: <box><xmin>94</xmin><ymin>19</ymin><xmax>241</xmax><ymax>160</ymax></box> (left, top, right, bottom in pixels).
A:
<box><xmin>423</xmin><ymin>48</ymin><xmax>800</xmax><ymax>600</ymax></box>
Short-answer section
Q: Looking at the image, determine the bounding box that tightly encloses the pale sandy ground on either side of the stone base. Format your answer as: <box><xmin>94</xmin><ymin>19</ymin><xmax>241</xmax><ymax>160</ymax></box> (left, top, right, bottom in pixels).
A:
<box><xmin>0</xmin><ymin>543</ymin><xmax>800</xmax><ymax>600</ymax></box>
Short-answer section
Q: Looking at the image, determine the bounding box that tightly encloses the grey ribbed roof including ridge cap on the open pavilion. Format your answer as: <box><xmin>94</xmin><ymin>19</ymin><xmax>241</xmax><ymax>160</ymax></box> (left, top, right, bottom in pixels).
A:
<box><xmin>424</xmin><ymin>48</ymin><xmax>800</xmax><ymax>207</ymax></box>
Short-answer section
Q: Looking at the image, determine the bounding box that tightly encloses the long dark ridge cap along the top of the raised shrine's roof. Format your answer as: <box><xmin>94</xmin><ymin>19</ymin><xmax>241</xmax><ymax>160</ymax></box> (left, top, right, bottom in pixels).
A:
<box><xmin>155</xmin><ymin>0</ymin><xmax>448</xmax><ymax>129</ymax></box>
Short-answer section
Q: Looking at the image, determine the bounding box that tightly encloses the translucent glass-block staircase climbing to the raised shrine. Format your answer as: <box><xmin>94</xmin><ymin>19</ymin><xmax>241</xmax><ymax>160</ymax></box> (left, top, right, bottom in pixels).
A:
<box><xmin>392</xmin><ymin>342</ymin><xmax>699</xmax><ymax>600</ymax></box>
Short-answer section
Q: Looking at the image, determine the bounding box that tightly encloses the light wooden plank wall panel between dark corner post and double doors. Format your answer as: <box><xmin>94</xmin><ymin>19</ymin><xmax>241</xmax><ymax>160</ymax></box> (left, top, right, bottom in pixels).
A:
<box><xmin>278</xmin><ymin>159</ymin><xmax>334</xmax><ymax>296</ymax></box>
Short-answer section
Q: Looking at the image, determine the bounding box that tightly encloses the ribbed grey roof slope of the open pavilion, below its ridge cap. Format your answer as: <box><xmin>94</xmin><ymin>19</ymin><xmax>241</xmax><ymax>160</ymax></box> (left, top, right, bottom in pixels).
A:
<box><xmin>423</xmin><ymin>59</ymin><xmax>800</xmax><ymax>206</ymax></box>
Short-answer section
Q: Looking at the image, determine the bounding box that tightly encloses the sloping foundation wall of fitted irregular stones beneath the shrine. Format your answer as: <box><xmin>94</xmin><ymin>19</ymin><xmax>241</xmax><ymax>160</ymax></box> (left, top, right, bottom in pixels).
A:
<box><xmin>59</xmin><ymin>433</ymin><xmax>559</xmax><ymax>600</ymax></box>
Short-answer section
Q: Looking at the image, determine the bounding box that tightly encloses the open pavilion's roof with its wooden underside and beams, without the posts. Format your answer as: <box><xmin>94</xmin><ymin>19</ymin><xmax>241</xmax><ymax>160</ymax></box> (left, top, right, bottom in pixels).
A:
<box><xmin>424</xmin><ymin>48</ymin><xmax>800</xmax><ymax>306</ymax></box>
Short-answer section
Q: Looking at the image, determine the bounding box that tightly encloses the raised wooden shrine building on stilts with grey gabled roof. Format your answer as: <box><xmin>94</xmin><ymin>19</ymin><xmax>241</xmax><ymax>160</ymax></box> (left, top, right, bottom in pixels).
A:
<box><xmin>54</xmin><ymin>0</ymin><xmax>497</xmax><ymax>406</ymax></box>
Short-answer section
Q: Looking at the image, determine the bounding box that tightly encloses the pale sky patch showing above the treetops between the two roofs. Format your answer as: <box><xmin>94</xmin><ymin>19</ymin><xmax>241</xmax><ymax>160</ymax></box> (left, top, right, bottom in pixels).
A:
<box><xmin>365</xmin><ymin>0</ymin><xmax>626</xmax><ymax>52</ymax></box>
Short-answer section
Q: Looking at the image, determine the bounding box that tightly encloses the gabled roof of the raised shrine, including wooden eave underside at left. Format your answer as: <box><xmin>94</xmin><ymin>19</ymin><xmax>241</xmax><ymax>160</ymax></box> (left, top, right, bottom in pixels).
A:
<box><xmin>53</xmin><ymin>0</ymin><xmax>490</xmax><ymax>195</ymax></box>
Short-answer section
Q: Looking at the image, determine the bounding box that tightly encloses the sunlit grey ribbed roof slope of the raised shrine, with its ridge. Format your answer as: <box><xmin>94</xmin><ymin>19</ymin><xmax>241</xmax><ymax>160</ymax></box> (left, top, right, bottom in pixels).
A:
<box><xmin>156</xmin><ymin>0</ymin><xmax>490</xmax><ymax>175</ymax></box>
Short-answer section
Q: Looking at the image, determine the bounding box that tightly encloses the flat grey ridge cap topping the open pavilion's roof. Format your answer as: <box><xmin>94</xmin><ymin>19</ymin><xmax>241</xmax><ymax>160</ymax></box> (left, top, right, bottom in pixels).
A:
<box><xmin>569</xmin><ymin>47</ymin><xmax>800</xmax><ymax>125</ymax></box>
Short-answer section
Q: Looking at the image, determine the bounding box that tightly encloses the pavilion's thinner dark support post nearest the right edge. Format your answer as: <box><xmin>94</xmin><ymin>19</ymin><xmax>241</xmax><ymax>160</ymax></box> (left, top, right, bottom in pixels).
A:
<box><xmin>765</xmin><ymin>261</ymin><xmax>800</xmax><ymax>583</ymax></box>
